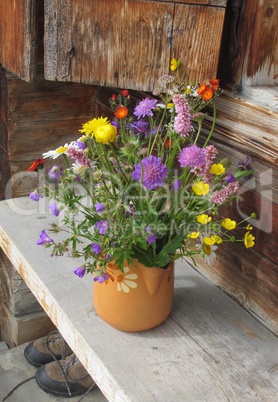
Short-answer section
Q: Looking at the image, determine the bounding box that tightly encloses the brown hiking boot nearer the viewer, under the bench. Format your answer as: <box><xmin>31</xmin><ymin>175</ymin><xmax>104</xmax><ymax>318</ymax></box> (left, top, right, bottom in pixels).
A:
<box><xmin>35</xmin><ymin>354</ymin><xmax>96</xmax><ymax>398</ymax></box>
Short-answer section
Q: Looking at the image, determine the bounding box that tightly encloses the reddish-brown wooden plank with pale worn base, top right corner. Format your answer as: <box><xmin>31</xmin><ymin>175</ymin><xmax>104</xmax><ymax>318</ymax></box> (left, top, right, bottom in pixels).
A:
<box><xmin>232</xmin><ymin>0</ymin><xmax>278</xmax><ymax>86</ymax></box>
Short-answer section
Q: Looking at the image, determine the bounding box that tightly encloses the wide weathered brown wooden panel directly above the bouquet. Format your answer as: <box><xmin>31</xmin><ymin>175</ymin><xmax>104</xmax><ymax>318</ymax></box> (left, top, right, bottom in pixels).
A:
<box><xmin>44</xmin><ymin>0</ymin><xmax>225</xmax><ymax>91</ymax></box>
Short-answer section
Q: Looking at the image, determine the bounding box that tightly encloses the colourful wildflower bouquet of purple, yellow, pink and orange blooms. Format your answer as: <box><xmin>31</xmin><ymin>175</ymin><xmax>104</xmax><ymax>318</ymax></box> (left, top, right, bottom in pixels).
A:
<box><xmin>31</xmin><ymin>59</ymin><xmax>254</xmax><ymax>282</ymax></box>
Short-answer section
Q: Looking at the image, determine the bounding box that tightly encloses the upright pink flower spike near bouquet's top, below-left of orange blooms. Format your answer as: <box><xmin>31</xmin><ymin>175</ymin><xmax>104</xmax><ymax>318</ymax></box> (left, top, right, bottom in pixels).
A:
<box><xmin>173</xmin><ymin>94</ymin><xmax>191</xmax><ymax>137</ymax></box>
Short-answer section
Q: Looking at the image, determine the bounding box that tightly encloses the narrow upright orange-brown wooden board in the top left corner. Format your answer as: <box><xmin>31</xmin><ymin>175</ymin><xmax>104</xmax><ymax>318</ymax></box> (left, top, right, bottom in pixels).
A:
<box><xmin>0</xmin><ymin>0</ymin><xmax>38</xmax><ymax>81</ymax></box>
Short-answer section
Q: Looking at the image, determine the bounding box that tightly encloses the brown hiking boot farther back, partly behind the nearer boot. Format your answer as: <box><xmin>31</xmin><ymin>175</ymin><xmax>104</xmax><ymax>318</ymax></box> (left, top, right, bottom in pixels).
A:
<box><xmin>24</xmin><ymin>331</ymin><xmax>72</xmax><ymax>367</ymax></box>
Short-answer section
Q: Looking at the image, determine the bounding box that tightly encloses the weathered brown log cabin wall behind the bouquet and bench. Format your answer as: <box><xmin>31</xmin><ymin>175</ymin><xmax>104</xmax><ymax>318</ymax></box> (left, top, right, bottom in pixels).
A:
<box><xmin>0</xmin><ymin>0</ymin><xmax>278</xmax><ymax>339</ymax></box>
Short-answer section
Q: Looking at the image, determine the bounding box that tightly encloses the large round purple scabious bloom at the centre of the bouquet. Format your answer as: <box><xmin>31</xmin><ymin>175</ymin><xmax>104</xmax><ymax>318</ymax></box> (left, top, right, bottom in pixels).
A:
<box><xmin>132</xmin><ymin>155</ymin><xmax>169</xmax><ymax>190</ymax></box>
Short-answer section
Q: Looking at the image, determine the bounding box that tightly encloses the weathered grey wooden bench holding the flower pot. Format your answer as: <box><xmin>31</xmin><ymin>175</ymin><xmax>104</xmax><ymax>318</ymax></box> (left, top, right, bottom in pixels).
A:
<box><xmin>0</xmin><ymin>197</ymin><xmax>278</xmax><ymax>402</ymax></box>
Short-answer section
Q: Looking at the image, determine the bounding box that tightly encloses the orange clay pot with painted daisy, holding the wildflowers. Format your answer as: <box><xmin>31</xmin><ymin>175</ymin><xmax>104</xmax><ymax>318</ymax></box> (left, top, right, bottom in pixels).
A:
<box><xmin>93</xmin><ymin>260</ymin><xmax>174</xmax><ymax>332</ymax></box>
